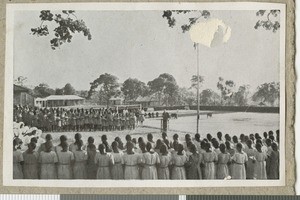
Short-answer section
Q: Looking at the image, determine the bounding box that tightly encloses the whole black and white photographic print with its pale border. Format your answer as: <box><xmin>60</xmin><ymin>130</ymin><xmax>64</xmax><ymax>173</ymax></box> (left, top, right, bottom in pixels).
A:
<box><xmin>3</xmin><ymin>3</ymin><xmax>285</xmax><ymax>187</ymax></box>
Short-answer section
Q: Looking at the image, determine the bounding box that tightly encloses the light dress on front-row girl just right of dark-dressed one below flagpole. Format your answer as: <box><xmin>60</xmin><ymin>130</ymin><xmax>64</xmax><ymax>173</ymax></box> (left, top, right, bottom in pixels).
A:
<box><xmin>203</xmin><ymin>151</ymin><xmax>218</xmax><ymax>179</ymax></box>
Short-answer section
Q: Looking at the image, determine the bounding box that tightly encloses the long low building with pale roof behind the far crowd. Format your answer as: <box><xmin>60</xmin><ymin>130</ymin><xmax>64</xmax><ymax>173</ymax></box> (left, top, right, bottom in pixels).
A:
<box><xmin>34</xmin><ymin>95</ymin><xmax>85</xmax><ymax>108</ymax></box>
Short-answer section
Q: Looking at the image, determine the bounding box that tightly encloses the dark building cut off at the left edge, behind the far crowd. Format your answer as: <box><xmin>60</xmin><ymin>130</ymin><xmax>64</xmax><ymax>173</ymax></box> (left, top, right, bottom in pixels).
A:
<box><xmin>14</xmin><ymin>84</ymin><xmax>34</xmax><ymax>106</ymax></box>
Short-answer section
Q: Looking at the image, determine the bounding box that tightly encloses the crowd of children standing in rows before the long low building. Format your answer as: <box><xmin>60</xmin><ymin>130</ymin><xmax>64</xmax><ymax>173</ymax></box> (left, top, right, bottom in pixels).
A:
<box><xmin>14</xmin><ymin>106</ymin><xmax>145</xmax><ymax>132</ymax></box>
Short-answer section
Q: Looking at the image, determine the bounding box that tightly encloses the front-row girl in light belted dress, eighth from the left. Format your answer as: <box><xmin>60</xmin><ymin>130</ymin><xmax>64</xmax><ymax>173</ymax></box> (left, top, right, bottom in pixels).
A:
<box><xmin>111</xmin><ymin>141</ymin><xmax>124</xmax><ymax>180</ymax></box>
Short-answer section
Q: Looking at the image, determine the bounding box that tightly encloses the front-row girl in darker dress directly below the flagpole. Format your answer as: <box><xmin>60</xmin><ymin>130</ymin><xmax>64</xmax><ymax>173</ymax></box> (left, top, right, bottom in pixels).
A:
<box><xmin>187</xmin><ymin>144</ymin><xmax>203</xmax><ymax>179</ymax></box>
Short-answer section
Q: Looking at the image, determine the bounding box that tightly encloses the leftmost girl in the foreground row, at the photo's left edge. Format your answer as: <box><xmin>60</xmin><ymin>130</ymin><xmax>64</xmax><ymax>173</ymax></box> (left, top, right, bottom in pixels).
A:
<box><xmin>13</xmin><ymin>138</ymin><xmax>24</xmax><ymax>179</ymax></box>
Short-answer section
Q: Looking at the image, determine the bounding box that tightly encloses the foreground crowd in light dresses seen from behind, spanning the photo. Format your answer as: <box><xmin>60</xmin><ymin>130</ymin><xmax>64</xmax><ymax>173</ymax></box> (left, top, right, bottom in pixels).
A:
<box><xmin>13</xmin><ymin>130</ymin><xmax>279</xmax><ymax>180</ymax></box>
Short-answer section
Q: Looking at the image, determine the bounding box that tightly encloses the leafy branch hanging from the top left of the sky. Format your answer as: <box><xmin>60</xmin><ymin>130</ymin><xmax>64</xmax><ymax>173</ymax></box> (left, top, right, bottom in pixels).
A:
<box><xmin>31</xmin><ymin>10</ymin><xmax>92</xmax><ymax>50</ymax></box>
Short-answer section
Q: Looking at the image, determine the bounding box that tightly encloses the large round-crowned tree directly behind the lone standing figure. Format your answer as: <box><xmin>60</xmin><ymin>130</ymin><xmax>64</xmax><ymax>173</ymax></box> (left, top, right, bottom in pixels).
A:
<box><xmin>148</xmin><ymin>73</ymin><xmax>179</xmax><ymax>106</ymax></box>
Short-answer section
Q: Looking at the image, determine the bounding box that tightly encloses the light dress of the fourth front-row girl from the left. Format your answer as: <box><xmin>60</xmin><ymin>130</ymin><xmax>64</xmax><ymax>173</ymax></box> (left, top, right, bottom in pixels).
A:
<box><xmin>57</xmin><ymin>151</ymin><xmax>74</xmax><ymax>179</ymax></box>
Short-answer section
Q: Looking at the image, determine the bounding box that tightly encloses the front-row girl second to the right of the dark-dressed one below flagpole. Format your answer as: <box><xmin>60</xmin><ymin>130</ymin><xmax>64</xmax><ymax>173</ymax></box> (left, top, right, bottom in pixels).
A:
<box><xmin>217</xmin><ymin>143</ymin><xmax>230</xmax><ymax>179</ymax></box>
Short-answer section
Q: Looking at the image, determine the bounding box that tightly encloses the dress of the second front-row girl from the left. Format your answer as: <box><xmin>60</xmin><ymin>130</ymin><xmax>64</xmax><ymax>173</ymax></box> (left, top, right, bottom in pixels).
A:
<box><xmin>23</xmin><ymin>151</ymin><xmax>39</xmax><ymax>179</ymax></box>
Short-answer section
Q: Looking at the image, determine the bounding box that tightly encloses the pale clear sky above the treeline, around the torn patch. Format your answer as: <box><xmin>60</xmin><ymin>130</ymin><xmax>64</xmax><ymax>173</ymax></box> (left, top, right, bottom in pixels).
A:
<box><xmin>14</xmin><ymin>11</ymin><xmax>280</xmax><ymax>90</ymax></box>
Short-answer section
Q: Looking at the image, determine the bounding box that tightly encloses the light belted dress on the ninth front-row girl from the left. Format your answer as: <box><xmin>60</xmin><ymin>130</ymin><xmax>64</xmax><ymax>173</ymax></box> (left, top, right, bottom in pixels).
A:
<box><xmin>122</xmin><ymin>153</ymin><xmax>141</xmax><ymax>180</ymax></box>
